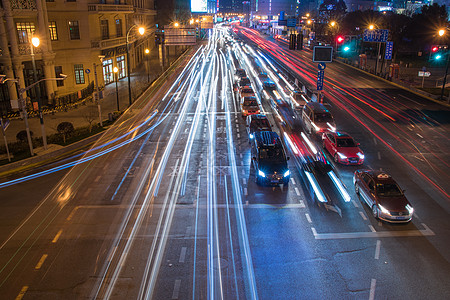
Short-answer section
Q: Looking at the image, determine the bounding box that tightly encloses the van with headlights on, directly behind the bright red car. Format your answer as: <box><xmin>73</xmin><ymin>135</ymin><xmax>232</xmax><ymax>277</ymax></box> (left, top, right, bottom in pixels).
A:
<box><xmin>302</xmin><ymin>102</ymin><xmax>336</xmax><ymax>134</ymax></box>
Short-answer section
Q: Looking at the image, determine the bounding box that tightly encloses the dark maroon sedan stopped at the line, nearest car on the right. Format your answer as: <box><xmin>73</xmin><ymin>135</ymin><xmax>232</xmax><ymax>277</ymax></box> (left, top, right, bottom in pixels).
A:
<box><xmin>353</xmin><ymin>170</ymin><xmax>414</xmax><ymax>223</ymax></box>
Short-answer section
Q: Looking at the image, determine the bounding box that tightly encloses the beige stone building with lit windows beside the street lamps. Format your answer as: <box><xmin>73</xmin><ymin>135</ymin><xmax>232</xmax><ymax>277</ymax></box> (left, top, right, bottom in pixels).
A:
<box><xmin>0</xmin><ymin>0</ymin><xmax>156</xmax><ymax>112</ymax></box>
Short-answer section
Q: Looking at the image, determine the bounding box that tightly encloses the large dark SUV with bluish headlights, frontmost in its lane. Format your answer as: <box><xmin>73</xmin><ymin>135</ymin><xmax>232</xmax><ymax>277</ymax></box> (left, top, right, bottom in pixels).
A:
<box><xmin>251</xmin><ymin>131</ymin><xmax>290</xmax><ymax>185</ymax></box>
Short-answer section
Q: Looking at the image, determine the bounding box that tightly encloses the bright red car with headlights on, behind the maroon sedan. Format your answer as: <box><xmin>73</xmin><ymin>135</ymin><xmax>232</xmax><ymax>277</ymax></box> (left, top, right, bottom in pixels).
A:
<box><xmin>322</xmin><ymin>131</ymin><xmax>364</xmax><ymax>165</ymax></box>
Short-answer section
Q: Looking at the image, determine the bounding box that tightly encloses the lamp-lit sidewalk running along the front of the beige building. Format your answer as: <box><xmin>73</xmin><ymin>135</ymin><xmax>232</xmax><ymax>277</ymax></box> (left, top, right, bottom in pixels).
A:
<box><xmin>0</xmin><ymin>49</ymin><xmax>181</xmax><ymax>145</ymax></box>
